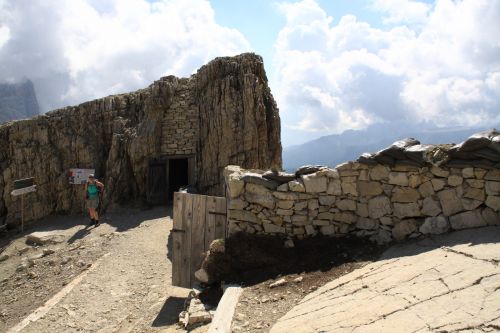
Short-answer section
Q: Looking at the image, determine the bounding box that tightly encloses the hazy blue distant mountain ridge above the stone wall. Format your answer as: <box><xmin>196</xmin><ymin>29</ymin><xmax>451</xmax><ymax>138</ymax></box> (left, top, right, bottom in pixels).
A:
<box><xmin>283</xmin><ymin>123</ymin><xmax>500</xmax><ymax>171</ymax></box>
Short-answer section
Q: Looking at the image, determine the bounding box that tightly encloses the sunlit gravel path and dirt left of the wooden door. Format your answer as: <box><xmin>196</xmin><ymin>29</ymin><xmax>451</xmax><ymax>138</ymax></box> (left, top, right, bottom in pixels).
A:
<box><xmin>0</xmin><ymin>208</ymin><xmax>188</xmax><ymax>332</ymax></box>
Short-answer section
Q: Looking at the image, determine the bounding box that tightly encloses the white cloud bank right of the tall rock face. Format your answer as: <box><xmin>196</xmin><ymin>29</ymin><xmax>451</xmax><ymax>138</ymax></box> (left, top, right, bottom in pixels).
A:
<box><xmin>273</xmin><ymin>0</ymin><xmax>500</xmax><ymax>143</ymax></box>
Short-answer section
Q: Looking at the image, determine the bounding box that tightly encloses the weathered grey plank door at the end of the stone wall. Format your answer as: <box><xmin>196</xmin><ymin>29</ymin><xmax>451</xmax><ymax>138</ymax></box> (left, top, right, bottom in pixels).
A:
<box><xmin>172</xmin><ymin>192</ymin><xmax>227</xmax><ymax>288</ymax></box>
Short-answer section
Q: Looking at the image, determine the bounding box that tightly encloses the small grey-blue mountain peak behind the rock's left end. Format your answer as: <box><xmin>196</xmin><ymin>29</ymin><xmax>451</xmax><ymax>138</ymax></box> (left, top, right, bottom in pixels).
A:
<box><xmin>0</xmin><ymin>80</ymin><xmax>40</xmax><ymax>123</ymax></box>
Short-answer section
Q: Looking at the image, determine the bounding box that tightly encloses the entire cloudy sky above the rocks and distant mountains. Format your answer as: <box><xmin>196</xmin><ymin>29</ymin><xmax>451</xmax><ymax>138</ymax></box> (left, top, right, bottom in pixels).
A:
<box><xmin>0</xmin><ymin>0</ymin><xmax>500</xmax><ymax>147</ymax></box>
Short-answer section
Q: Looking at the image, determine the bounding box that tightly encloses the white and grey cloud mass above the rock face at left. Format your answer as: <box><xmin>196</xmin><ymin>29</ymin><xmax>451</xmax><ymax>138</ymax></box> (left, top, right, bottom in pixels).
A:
<box><xmin>0</xmin><ymin>0</ymin><xmax>250</xmax><ymax>111</ymax></box>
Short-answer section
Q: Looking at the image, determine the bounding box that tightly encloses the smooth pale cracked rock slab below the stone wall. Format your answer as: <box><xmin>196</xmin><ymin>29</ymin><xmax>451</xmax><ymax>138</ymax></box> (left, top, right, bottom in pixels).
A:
<box><xmin>271</xmin><ymin>227</ymin><xmax>500</xmax><ymax>333</ymax></box>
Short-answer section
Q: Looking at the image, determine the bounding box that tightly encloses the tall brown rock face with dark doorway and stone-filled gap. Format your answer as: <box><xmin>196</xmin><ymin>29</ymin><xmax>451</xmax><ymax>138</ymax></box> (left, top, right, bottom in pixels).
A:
<box><xmin>0</xmin><ymin>54</ymin><xmax>281</xmax><ymax>224</ymax></box>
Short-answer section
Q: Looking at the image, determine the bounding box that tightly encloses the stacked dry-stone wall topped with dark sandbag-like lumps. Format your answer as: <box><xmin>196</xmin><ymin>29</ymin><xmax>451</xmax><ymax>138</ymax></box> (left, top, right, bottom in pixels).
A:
<box><xmin>225</xmin><ymin>131</ymin><xmax>500</xmax><ymax>243</ymax></box>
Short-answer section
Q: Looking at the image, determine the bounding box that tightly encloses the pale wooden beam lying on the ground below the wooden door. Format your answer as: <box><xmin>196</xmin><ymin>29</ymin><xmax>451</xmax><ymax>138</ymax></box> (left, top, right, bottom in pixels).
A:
<box><xmin>208</xmin><ymin>285</ymin><xmax>243</xmax><ymax>333</ymax></box>
